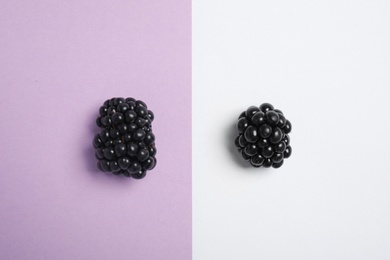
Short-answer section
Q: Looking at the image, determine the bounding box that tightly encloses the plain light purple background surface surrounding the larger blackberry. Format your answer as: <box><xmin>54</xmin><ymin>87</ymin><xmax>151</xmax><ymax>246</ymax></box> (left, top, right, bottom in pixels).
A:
<box><xmin>0</xmin><ymin>0</ymin><xmax>191</xmax><ymax>259</ymax></box>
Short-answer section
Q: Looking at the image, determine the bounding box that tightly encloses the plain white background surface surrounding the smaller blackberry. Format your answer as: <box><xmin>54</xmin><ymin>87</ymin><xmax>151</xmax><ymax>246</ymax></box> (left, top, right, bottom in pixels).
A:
<box><xmin>193</xmin><ymin>0</ymin><xmax>390</xmax><ymax>260</ymax></box>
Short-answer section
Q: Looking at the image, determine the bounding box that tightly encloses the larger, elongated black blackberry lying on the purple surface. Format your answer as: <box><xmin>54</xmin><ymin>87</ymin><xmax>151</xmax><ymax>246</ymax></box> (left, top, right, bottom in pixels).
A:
<box><xmin>92</xmin><ymin>98</ymin><xmax>157</xmax><ymax>179</ymax></box>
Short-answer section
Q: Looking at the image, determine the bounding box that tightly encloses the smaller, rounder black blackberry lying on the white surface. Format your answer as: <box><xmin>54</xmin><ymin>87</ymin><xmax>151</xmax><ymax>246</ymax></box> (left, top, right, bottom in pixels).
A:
<box><xmin>235</xmin><ymin>103</ymin><xmax>292</xmax><ymax>169</ymax></box>
